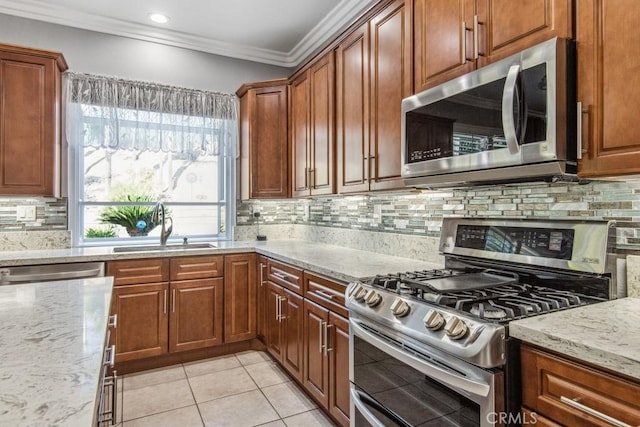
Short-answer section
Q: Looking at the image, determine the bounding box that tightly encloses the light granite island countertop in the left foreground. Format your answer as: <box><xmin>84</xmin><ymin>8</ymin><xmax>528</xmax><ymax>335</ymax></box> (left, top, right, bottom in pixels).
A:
<box><xmin>0</xmin><ymin>277</ymin><xmax>113</xmax><ymax>426</ymax></box>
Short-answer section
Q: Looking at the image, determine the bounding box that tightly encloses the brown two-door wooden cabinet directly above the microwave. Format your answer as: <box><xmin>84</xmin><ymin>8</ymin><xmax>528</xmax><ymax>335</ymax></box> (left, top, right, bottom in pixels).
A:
<box><xmin>413</xmin><ymin>0</ymin><xmax>574</xmax><ymax>92</ymax></box>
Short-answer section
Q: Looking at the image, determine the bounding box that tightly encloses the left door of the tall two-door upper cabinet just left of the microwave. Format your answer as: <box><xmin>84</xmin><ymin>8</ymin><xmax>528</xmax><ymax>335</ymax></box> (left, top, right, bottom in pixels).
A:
<box><xmin>336</xmin><ymin>23</ymin><xmax>370</xmax><ymax>193</ymax></box>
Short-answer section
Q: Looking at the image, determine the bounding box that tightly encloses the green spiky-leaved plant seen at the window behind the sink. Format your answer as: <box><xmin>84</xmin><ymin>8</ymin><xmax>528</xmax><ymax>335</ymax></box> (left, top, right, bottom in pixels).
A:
<box><xmin>100</xmin><ymin>194</ymin><xmax>156</xmax><ymax>237</ymax></box>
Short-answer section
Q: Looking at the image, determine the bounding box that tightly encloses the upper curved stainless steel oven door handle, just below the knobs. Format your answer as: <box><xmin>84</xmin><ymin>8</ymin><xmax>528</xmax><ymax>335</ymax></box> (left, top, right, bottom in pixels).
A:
<box><xmin>349</xmin><ymin>319</ymin><xmax>491</xmax><ymax>397</ymax></box>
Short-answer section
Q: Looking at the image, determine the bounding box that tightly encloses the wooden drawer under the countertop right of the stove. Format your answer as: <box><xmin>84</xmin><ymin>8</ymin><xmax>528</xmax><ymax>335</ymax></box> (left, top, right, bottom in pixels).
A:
<box><xmin>522</xmin><ymin>346</ymin><xmax>640</xmax><ymax>426</ymax></box>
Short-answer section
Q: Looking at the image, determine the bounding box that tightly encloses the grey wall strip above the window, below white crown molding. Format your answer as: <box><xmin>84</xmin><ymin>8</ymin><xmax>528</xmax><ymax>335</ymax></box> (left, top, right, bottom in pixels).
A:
<box><xmin>0</xmin><ymin>14</ymin><xmax>292</xmax><ymax>93</ymax></box>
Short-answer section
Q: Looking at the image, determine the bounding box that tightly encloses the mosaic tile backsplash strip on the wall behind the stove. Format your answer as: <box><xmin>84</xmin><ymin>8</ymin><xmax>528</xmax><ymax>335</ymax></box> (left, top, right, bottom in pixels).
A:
<box><xmin>237</xmin><ymin>180</ymin><xmax>640</xmax><ymax>253</ymax></box>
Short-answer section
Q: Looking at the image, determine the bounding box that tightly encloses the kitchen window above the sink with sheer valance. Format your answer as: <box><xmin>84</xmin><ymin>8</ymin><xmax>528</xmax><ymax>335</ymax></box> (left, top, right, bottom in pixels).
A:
<box><xmin>67</xmin><ymin>74</ymin><xmax>237</xmax><ymax>246</ymax></box>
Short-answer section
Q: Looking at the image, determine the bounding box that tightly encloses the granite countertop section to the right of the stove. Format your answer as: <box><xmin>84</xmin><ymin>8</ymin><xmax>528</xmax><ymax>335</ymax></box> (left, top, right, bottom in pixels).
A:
<box><xmin>509</xmin><ymin>298</ymin><xmax>640</xmax><ymax>381</ymax></box>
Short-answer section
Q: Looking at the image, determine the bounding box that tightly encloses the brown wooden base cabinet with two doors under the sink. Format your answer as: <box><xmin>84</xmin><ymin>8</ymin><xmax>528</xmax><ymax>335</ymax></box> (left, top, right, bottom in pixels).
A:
<box><xmin>107</xmin><ymin>256</ymin><xmax>224</xmax><ymax>362</ymax></box>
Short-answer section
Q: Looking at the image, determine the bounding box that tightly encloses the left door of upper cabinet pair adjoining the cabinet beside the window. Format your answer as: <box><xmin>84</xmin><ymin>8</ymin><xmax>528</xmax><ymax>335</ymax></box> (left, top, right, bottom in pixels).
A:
<box><xmin>289</xmin><ymin>70</ymin><xmax>311</xmax><ymax>197</ymax></box>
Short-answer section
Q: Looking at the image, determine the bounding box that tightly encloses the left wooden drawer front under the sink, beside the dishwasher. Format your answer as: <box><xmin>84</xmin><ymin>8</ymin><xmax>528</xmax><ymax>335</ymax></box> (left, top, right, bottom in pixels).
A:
<box><xmin>107</xmin><ymin>259</ymin><xmax>169</xmax><ymax>286</ymax></box>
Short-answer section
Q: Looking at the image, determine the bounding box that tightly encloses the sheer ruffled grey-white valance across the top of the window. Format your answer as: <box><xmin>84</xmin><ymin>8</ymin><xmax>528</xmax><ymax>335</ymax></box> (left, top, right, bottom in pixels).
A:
<box><xmin>66</xmin><ymin>73</ymin><xmax>238</xmax><ymax>156</ymax></box>
